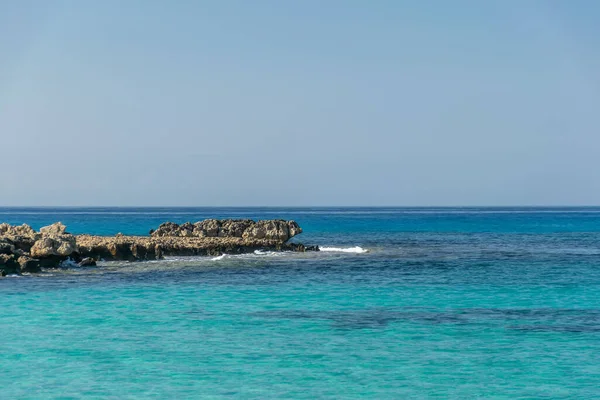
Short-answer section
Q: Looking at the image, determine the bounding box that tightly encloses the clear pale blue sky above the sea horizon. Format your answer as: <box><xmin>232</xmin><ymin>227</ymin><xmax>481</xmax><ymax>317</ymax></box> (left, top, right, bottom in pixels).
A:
<box><xmin>0</xmin><ymin>0</ymin><xmax>600</xmax><ymax>206</ymax></box>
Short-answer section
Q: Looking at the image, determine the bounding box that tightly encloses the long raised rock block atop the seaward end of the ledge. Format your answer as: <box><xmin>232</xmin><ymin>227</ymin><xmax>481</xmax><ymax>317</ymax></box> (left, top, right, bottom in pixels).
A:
<box><xmin>150</xmin><ymin>219</ymin><xmax>302</xmax><ymax>242</ymax></box>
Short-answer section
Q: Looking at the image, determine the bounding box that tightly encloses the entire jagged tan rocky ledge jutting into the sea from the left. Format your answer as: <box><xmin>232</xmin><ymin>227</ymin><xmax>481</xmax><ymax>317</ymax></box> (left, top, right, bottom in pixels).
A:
<box><xmin>0</xmin><ymin>219</ymin><xmax>319</xmax><ymax>276</ymax></box>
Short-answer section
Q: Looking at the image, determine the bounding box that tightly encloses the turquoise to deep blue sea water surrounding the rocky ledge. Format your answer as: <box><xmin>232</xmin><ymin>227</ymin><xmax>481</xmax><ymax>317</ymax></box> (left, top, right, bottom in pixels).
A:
<box><xmin>0</xmin><ymin>208</ymin><xmax>600</xmax><ymax>399</ymax></box>
